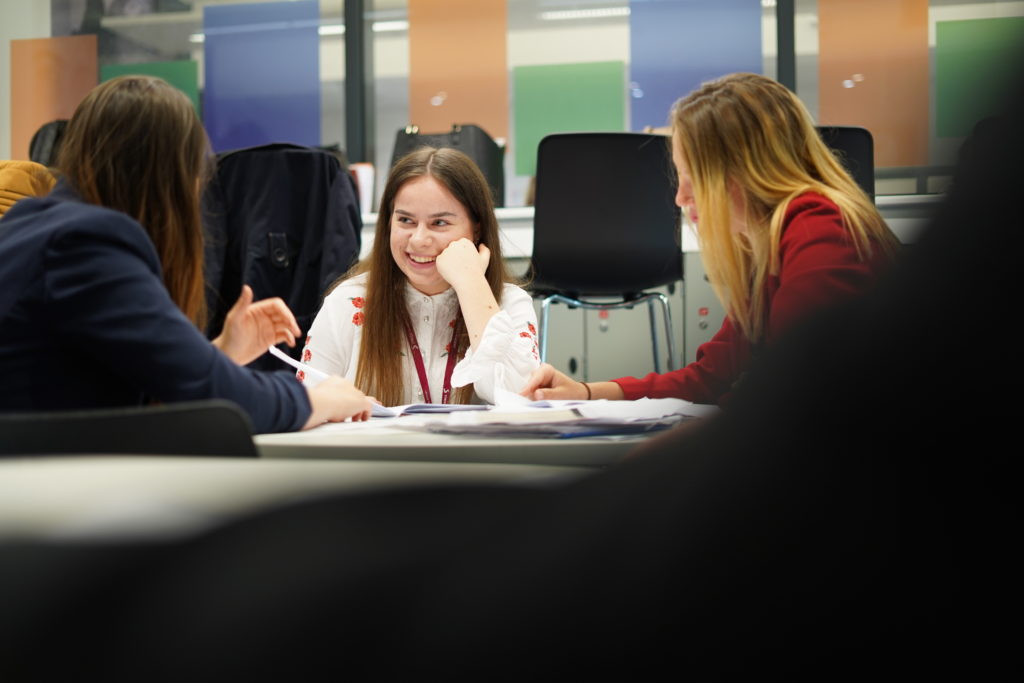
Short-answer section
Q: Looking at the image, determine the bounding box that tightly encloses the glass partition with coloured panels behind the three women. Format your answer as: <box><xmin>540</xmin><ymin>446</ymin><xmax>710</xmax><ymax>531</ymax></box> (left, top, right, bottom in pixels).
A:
<box><xmin>28</xmin><ymin>0</ymin><xmax>1024</xmax><ymax>205</ymax></box>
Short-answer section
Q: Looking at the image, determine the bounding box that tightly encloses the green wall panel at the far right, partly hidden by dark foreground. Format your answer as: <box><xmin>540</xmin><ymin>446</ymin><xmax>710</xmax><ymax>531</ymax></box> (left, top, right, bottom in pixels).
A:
<box><xmin>935</xmin><ymin>16</ymin><xmax>1024</xmax><ymax>137</ymax></box>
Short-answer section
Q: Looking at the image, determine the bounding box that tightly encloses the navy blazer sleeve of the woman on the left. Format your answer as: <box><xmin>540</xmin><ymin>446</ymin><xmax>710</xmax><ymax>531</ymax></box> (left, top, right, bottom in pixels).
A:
<box><xmin>35</xmin><ymin>205</ymin><xmax>310</xmax><ymax>432</ymax></box>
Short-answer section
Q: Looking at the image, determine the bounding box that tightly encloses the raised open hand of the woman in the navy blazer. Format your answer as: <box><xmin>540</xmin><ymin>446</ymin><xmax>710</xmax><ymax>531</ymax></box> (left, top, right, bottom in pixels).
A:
<box><xmin>213</xmin><ymin>285</ymin><xmax>301</xmax><ymax>366</ymax></box>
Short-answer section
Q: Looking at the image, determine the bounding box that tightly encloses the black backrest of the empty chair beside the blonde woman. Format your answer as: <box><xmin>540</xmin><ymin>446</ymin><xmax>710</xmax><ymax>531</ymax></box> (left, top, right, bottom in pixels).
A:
<box><xmin>531</xmin><ymin>133</ymin><xmax>682</xmax><ymax>296</ymax></box>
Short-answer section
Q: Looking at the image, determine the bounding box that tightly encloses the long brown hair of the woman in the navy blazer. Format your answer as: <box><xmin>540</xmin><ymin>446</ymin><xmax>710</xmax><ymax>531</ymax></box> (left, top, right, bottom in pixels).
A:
<box><xmin>57</xmin><ymin>76</ymin><xmax>210</xmax><ymax>329</ymax></box>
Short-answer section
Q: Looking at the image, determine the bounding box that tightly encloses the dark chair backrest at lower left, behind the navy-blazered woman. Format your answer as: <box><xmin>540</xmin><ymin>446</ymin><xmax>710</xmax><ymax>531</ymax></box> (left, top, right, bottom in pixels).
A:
<box><xmin>0</xmin><ymin>400</ymin><xmax>258</xmax><ymax>458</ymax></box>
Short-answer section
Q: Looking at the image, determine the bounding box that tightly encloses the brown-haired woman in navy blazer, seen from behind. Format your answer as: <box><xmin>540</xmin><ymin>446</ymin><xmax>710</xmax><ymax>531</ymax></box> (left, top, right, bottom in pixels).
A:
<box><xmin>0</xmin><ymin>76</ymin><xmax>371</xmax><ymax>432</ymax></box>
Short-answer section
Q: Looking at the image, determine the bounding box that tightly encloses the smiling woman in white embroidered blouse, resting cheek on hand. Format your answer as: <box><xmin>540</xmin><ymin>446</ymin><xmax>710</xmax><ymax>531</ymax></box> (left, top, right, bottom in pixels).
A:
<box><xmin>300</xmin><ymin>147</ymin><xmax>539</xmax><ymax>405</ymax></box>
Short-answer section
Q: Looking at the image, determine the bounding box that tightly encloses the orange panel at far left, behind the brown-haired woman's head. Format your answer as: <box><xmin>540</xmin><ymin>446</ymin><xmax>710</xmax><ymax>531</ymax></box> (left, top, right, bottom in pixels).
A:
<box><xmin>10</xmin><ymin>36</ymin><xmax>99</xmax><ymax>159</ymax></box>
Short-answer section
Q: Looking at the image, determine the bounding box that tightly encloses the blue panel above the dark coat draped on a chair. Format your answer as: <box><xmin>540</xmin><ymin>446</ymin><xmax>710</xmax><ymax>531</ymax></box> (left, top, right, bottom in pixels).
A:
<box><xmin>203</xmin><ymin>0</ymin><xmax>321</xmax><ymax>152</ymax></box>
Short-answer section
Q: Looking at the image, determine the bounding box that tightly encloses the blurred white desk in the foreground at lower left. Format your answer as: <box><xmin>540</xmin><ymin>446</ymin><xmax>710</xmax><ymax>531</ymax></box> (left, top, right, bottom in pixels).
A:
<box><xmin>0</xmin><ymin>456</ymin><xmax>594</xmax><ymax>542</ymax></box>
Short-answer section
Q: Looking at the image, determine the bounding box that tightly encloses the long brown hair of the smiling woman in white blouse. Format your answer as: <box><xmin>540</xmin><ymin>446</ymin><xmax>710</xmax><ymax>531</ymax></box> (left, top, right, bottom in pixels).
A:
<box><xmin>346</xmin><ymin>147</ymin><xmax>513</xmax><ymax>405</ymax></box>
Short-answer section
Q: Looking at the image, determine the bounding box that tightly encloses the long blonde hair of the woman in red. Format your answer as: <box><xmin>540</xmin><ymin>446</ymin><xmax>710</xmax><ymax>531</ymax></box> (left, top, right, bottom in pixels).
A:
<box><xmin>672</xmin><ymin>74</ymin><xmax>898</xmax><ymax>341</ymax></box>
